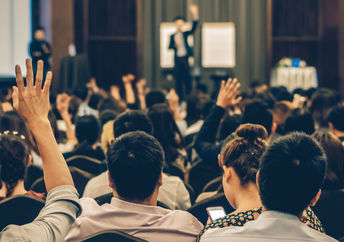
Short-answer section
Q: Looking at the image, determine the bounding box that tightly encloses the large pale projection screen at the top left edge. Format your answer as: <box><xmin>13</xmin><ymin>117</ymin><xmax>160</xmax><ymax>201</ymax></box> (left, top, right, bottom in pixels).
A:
<box><xmin>0</xmin><ymin>0</ymin><xmax>31</xmax><ymax>76</ymax></box>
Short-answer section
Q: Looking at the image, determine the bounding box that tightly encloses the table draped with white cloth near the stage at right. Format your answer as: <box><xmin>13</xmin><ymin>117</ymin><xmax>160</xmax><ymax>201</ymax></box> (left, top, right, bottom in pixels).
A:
<box><xmin>270</xmin><ymin>66</ymin><xmax>318</xmax><ymax>92</ymax></box>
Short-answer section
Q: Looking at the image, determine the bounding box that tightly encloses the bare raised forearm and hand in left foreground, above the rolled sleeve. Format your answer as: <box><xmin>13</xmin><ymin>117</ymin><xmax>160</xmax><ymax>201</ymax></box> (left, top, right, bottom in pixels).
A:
<box><xmin>12</xmin><ymin>59</ymin><xmax>74</xmax><ymax>192</ymax></box>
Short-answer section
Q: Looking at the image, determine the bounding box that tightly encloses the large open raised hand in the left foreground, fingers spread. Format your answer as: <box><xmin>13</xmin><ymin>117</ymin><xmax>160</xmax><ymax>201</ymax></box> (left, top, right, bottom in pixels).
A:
<box><xmin>12</xmin><ymin>58</ymin><xmax>52</xmax><ymax>129</ymax></box>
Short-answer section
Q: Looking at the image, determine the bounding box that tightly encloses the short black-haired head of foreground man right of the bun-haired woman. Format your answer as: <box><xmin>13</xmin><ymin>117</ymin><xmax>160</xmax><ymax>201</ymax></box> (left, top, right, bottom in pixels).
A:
<box><xmin>258</xmin><ymin>132</ymin><xmax>326</xmax><ymax>215</ymax></box>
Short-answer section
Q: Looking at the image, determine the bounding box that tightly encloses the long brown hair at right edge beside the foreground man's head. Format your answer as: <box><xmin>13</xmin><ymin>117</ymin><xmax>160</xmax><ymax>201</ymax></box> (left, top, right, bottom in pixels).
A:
<box><xmin>312</xmin><ymin>131</ymin><xmax>344</xmax><ymax>190</ymax></box>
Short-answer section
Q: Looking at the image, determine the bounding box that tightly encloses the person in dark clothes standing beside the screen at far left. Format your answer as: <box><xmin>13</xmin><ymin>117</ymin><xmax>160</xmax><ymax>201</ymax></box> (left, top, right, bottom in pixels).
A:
<box><xmin>30</xmin><ymin>27</ymin><xmax>51</xmax><ymax>76</ymax></box>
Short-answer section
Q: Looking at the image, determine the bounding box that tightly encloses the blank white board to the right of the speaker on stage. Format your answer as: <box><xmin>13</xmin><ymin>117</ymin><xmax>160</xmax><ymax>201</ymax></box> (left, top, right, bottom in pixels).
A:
<box><xmin>202</xmin><ymin>23</ymin><xmax>235</xmax><ymax>68</ymax></box>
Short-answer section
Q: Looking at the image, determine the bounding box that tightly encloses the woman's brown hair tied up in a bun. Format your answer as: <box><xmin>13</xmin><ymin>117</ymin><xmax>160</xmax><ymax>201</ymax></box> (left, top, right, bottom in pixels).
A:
<box><xmin>221</xmin><ymin>124</ymin><xmax>268</xmax><ymax>186</ymax></box>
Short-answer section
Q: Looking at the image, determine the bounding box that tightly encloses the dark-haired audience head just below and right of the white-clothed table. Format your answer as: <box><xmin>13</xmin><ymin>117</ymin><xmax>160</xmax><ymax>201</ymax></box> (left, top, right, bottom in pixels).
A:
<box><xmin>310</xmin><ymin>88</ymin><xmax>340</xmax><ymax>127</ymax></box>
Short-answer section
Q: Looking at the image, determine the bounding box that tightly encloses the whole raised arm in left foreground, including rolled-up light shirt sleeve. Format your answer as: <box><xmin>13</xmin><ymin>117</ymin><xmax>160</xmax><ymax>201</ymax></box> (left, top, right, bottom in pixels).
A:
<box><xmin>0</xmin><ymin>59</ymin><xmax>81</xmax><ymax>241</ymax></box>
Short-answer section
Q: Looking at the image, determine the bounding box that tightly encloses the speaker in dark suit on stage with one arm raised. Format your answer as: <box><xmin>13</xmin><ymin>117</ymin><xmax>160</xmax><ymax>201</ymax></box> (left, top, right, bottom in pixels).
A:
<box><xmin>168</xmin><ymin>4</ymin><xmax>199</xmax><ymax>100</ymax></box>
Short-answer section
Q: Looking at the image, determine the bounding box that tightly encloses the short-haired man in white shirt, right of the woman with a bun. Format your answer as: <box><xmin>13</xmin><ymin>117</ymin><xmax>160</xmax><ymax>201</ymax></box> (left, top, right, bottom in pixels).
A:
<box><xmin>201</xmin><ymin>133</ymin><xmax>336</xmax><ymax>242</ymax></box>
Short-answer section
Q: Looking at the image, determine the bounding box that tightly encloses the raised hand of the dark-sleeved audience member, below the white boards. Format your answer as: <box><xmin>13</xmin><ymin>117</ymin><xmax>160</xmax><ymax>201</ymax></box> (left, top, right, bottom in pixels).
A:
<box><xmin>216</xmin><ymin>78</ymin><xmax>241</xmax><ymax>109</ymax></box>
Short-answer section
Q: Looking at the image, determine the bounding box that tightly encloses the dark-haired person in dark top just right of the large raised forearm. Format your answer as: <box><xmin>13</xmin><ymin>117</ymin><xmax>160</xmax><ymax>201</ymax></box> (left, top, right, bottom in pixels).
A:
<box><xmin>64</xmin><ymin>115</ymin><xmax>105</xmax><ymax>161</ymax></box>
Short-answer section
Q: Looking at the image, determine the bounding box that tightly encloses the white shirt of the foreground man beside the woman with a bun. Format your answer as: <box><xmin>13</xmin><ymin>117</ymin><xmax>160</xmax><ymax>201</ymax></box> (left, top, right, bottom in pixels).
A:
<box><xmin>200</xmin><ymin>211</ymin><xmax>337</xmax><ymax>242</ymax></box>
